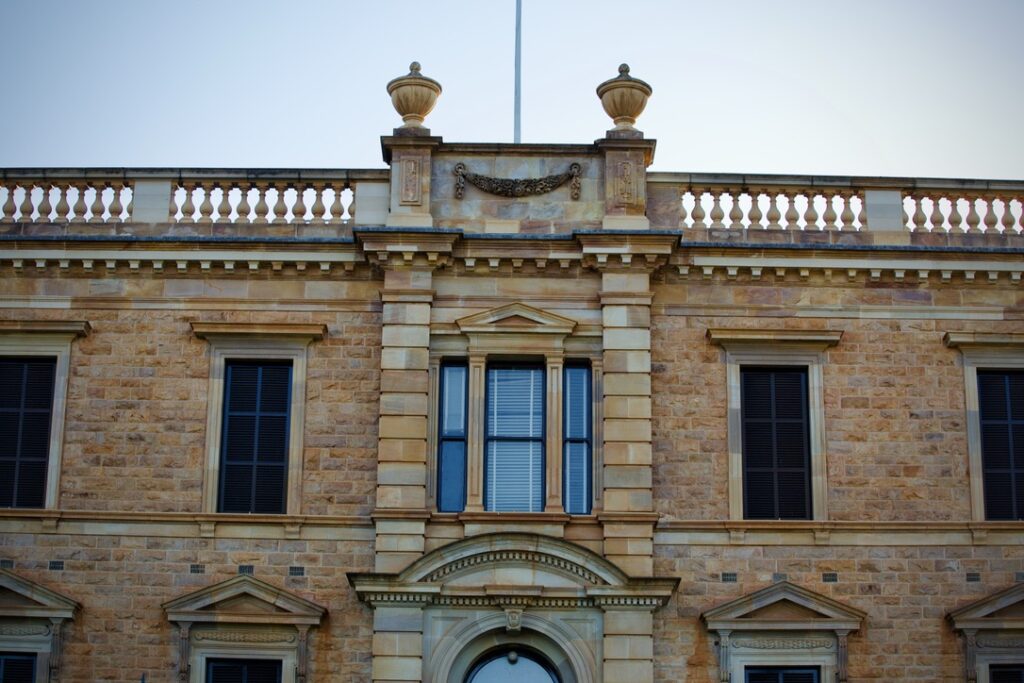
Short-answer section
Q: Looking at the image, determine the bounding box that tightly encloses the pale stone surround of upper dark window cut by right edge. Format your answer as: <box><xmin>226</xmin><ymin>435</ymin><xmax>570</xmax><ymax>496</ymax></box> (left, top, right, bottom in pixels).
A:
<box><xmin>942</xmin><ymin>332</ymin><xmax>1024</xmax><ymax>521</ymax></box>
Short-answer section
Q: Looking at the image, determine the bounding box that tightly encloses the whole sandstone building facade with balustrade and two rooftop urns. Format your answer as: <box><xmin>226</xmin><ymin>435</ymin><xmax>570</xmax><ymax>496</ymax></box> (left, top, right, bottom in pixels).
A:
<box><xmin>0</xmin><ymin>65</ymin><xmax>1024</xmax><ymax>683</ymax></box>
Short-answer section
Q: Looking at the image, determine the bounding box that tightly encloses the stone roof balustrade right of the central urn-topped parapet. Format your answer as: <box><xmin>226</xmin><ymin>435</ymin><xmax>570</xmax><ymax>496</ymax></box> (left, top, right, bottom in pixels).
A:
<box><xmin>647</xmin><ymin>173</ymin><xmax>1024</xmax><ymax>234</ymax></box>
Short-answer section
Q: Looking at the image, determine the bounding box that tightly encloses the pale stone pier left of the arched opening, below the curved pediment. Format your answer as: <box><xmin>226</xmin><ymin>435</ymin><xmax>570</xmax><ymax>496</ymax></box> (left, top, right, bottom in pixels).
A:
<box><xmin>372</xmin><ymin>603</ymin><xmax>423</xmax><ymax>683</ymax></box>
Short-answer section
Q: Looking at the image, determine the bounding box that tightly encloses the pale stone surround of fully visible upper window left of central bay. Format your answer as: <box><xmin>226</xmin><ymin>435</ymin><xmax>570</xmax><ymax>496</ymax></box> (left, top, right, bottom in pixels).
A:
<box><xmin>191</xmin><ymin>322</ymin><xmax>327</xmax><ymax>515</ymax></box>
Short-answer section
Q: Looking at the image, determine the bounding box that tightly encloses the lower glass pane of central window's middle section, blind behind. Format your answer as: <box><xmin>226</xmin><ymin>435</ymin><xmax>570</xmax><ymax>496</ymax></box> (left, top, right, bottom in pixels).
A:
<box><xmin>484</xmin><ymin>441</ymin><xmax>544</xmax><ymax>512</ymax></box>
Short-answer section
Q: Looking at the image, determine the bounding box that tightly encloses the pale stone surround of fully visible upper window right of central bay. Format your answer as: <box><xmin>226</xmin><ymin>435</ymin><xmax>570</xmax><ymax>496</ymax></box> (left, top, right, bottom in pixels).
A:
<box><xmin>708</xmin><ymin>329</ymin><xmax>843</xmax><ymax>521</ymax></box>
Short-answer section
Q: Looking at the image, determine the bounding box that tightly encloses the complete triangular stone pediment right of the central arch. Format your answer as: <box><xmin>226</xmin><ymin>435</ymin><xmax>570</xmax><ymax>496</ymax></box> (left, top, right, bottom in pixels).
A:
<box><xmin>700</xmin><ymin>582</ymin><xmax>864</xmax><ymax>631</ymax></box>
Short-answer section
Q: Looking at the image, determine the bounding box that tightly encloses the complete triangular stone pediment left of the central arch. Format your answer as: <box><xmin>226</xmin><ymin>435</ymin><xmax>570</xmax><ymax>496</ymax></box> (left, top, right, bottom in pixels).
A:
<box><xmin>163</xmin><ymin>575</ymin><xmax>327</xmax><ymax>625</ymax></box>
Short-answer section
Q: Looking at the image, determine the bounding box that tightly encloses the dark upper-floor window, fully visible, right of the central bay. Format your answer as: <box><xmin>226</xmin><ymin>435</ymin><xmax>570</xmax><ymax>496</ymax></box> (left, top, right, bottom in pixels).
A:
<box><xmin>740</xmin><ymin>366</ymin><xmax>812</xmax><ymax>519</ymax></box>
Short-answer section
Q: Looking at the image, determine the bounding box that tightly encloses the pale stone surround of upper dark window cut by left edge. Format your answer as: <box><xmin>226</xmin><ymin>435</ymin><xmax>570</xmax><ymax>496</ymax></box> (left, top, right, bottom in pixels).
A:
<box><xmin>0</xmin><ymin>321</ymin><xmax>91</xmax><ymax>510</ymax></box>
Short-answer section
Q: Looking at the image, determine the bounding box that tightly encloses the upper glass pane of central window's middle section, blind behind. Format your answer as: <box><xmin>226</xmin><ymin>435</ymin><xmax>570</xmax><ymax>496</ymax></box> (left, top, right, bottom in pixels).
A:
<box><xmin>487</xmin><ymin>368</ymin><xmax>544</xmax><ymax>437</ymax></box>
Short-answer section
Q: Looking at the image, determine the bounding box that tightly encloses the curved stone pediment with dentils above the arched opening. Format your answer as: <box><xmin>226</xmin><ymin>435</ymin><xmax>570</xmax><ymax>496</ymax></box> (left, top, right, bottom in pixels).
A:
<box><xmin>349</xmin><ymin>532</ymin><xmax>678</xmax><ymax>607</ymax></box>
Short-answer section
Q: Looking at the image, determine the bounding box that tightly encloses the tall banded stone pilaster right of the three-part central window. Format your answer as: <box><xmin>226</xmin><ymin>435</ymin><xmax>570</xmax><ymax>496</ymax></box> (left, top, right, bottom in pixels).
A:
<box><xmin>601</xmin><ymin>270</ymin><xmax>653</xmax><ymax>577</ymax></box>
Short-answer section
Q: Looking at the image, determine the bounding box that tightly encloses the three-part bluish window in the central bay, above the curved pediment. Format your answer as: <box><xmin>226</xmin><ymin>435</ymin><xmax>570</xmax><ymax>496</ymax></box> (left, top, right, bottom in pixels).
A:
<box><xmin>436</xmin><ymin>360</ymin><xmax>593</xmax><ymax>514</ymax></box>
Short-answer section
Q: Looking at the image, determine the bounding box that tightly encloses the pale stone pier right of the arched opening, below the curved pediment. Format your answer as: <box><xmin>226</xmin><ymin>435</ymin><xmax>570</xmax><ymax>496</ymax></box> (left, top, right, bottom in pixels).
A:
<box><xmin>602</xmin><ymin>607</ymin><xmax>654</xmax><ymax>683</ymax></box>
